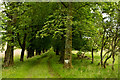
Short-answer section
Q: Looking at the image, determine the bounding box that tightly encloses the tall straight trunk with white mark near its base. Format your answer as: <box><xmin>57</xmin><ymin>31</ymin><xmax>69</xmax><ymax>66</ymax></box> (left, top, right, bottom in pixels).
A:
<box><xmin>64</xmin><ymin>2</ymin><xmax>73</xmax><ymax>68</ymax></box>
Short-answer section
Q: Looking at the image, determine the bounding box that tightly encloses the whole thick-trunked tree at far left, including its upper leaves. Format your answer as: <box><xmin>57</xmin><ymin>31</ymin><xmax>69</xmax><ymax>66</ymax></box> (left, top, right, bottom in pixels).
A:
<box><xmin>3</xmin><ymin>2</ymin><xmax>16</xmax><ymax>67</ymax></box>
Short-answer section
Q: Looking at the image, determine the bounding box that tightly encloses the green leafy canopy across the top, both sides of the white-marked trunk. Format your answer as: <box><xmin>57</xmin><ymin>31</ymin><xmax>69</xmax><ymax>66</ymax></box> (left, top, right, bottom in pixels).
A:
<box><xmin>3</xmin><ymin>2</ymin><xmax>117</xmax><ymax>50</ymax></box>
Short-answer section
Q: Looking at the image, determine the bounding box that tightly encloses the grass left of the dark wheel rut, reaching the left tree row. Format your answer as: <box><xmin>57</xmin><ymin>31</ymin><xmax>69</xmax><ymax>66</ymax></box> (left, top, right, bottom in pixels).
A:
<box><xmin>2</xmin><ymin>54</ymin><xmax>60</xmax><ymax>78</ymax></box>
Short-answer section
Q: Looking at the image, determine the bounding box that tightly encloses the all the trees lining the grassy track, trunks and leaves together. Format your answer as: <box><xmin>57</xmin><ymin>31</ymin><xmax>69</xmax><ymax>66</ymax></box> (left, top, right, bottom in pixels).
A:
<box><xmin>0</xmin><ymin>2</ymin><xmax>120</xmax><ymax>70</ymax></box>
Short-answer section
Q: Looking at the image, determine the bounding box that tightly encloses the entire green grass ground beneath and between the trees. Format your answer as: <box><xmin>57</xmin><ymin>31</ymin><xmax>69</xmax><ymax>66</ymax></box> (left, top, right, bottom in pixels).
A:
<box><xmin>2</xmin><ymin>51</ymin><xmax>118</xmax><ymax>78</ymax></box>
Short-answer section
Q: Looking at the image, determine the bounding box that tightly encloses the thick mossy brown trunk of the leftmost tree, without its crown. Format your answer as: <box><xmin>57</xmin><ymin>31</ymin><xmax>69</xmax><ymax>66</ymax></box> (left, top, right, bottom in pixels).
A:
<box><xmin>3</xmin><ymin>13</ymin><xmax>16</xmax><ymax>67</ymax></box>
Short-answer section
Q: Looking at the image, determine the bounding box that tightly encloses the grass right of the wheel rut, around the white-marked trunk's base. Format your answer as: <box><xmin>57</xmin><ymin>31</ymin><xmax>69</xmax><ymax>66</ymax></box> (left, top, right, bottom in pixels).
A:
<box><xmin>48</xmin><ymin>50</ymin><xmax>118</xmax><ymax>78</ymax></box>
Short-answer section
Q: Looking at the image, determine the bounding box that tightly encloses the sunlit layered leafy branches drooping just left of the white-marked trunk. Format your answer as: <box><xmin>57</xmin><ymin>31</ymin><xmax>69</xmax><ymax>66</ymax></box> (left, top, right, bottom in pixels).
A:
<box><xmin>40</xmin><ymin>9</ymin><xmax>68</xmax><ymax>38</ymax></box>
